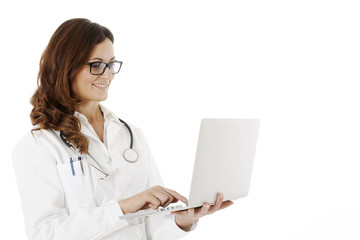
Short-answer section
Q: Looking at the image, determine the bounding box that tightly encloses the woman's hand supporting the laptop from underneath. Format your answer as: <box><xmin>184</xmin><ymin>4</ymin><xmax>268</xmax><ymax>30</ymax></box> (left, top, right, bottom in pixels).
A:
<box><xmin>171</xmin><ymin>193</ymin><xmax>234</xmax><ymax>230</ymax></box>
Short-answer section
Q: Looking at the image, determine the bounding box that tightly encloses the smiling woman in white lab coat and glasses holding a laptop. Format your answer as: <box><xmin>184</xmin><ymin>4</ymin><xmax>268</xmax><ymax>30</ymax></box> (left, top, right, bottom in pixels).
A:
<box><xmin>13</xmin><ymin>19</ymin><xmax>232</xmax><ymax>240</ymax></box>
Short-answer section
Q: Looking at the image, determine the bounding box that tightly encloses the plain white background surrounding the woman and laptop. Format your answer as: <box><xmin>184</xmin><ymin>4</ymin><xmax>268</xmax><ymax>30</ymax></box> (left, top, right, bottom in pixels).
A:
<box><xmin>0</xmin><ymin>0</ymin><xmax>360</xmax><ymax>240</ymax></box>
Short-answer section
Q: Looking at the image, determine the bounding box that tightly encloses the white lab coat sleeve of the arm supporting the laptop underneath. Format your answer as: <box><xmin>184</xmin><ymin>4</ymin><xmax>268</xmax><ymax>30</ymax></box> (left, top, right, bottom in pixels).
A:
<box><xmin>134</xmin><ymin>130</ymin><xmax>198</xmax><ymax>240</ymax></box>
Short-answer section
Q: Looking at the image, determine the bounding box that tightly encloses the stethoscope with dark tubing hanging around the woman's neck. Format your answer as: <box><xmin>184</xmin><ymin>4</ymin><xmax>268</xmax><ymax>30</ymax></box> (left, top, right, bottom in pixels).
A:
<box><xmin>60</xmin><ymin>118</ymin><xmax>139</xmax><ymax>177</ymax></box>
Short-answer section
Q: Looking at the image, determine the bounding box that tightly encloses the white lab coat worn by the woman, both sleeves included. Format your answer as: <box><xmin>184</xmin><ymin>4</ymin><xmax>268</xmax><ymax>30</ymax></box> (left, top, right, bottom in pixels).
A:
<box><xmin>13</xmin><ymin>106</ymin><xmax>195</xmax><ymax>240</ymax></box>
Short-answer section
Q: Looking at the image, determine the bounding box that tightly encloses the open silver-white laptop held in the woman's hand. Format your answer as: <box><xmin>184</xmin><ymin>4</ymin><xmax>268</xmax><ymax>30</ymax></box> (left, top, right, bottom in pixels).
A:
<box><xmin>120</xmin><ymin>118</ymin><xmax>260</xmax><ymax>219</ymax></box>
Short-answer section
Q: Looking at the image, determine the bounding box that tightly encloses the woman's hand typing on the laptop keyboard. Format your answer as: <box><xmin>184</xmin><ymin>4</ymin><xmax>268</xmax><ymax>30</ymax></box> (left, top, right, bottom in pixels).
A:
<box><xmin>118</xmin><ymin>186</ymin><xmax>188</xmax><ymax>214</ymax></box>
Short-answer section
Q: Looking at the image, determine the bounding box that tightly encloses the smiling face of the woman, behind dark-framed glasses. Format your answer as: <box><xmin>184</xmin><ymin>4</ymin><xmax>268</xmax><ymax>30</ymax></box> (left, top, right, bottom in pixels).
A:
<box><xmin>72</xmin><ymin>38</ymin><xmax>115</xmax><ymax>104</ymax></box>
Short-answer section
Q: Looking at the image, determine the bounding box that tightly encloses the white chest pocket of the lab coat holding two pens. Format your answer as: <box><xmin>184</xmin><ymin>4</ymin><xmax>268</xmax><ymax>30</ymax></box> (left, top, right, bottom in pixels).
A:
<box><xmin>58</xmin><ymin>160</ymin><xmax>96</xmax><ymax>210</ymax></box>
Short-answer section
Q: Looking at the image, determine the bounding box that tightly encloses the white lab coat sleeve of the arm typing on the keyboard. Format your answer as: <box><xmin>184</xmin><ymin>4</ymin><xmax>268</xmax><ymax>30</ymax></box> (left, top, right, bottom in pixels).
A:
<box><xmin>12</xmin><ymin>134</ymin><xmax>127</xmax><ymax>240</ymax></box>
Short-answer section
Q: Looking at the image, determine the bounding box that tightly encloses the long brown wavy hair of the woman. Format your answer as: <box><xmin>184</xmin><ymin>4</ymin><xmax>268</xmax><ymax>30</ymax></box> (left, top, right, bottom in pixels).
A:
<box><xmin>30</xmin><ymin>18</ymin><xmax>114</xmax><ymax>153</ymax></box>
